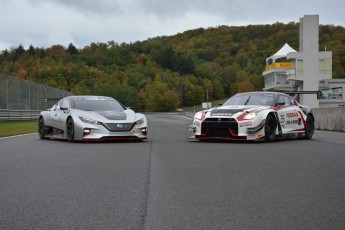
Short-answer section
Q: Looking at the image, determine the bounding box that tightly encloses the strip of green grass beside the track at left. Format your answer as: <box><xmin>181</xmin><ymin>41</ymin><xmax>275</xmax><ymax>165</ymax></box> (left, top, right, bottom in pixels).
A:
<box><xmin>0</xmin><ymin>120</ymin><xmax>37</xmax><ymax>137</ymax></box>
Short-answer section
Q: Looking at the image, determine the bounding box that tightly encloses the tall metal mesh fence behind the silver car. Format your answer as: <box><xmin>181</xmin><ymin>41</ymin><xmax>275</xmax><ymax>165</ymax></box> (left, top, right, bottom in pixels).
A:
<box><xmin>0</xmin><ymin>74</ymin><xmax>72</xmax><ymax>111</ymax></box>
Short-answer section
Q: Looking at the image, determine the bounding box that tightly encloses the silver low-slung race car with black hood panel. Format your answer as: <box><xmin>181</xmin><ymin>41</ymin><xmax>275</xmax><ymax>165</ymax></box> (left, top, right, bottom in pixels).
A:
<box><xmin>38</xmin><ymin>96</ymin><xmax>147</xmax><ymax>141</ymax></box>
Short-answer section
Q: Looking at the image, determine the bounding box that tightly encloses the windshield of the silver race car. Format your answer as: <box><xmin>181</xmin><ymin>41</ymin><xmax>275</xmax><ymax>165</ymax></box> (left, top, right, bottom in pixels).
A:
<box><xmin>74</xmin><ymin>100</ymin><xmax>125</xmax><ymax>111</ymax></box>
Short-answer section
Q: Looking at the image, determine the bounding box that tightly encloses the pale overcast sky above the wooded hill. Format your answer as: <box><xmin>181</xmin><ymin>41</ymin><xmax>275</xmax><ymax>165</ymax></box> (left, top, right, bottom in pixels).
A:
<box><xmin>0</xmin><ymin>0</ymin><xmax>345</xmax><ymax>50</ymax></box>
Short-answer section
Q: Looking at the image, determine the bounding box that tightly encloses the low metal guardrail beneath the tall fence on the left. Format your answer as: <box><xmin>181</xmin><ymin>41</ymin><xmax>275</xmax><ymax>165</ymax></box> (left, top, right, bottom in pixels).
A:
<box><xmin>0</xmin><ymin>109</ymin><xmax>41</xmax><ymax>122</ymax></box>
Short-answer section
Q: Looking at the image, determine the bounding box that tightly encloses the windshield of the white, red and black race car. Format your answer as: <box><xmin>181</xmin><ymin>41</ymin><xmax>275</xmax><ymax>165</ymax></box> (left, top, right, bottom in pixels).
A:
<box><xmin>223</xmin><ymin>94</ymin><xmax>274</xmax><ymax>106</ymax></box>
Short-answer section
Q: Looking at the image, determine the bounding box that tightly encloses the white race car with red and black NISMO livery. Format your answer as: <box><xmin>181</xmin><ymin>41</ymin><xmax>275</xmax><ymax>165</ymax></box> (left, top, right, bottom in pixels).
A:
<box><xmin>189</xmin><ymin>92</ymin><xmax>314</xmax><ymax>142</ymax></box>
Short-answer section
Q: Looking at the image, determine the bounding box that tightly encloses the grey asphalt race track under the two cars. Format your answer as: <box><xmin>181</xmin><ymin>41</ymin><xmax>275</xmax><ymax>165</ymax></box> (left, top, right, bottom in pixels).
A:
<box><xmin>0</xmin><ymin>114</ymin><xmax>345</xmax><ymax>230</ymax></box>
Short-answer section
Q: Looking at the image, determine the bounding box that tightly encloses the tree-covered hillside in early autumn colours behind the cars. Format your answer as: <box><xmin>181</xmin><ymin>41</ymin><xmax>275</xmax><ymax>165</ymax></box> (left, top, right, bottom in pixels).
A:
<box><xmin>0</xmin><ymin>22</ymin><xmax>345</xmax><ymax>111</ymax></box>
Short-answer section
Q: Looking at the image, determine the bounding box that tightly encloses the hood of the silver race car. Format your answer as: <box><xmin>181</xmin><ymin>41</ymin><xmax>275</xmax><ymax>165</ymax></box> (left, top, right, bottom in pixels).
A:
<box><xmin>75</xmin><ymin>109</ymin><xmax>136</xmax><ymax>122</ymax></box>
